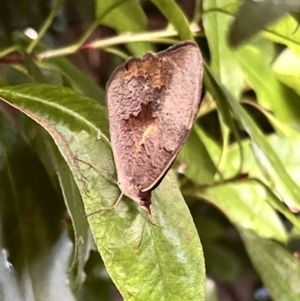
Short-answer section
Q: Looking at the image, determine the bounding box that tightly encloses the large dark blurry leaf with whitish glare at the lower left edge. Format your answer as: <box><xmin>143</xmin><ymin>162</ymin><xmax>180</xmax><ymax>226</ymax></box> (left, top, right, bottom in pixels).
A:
<box><xmin>0</xmin><ymin>113</ymin><xmax>74</xmax><ymax>301</ymax></box>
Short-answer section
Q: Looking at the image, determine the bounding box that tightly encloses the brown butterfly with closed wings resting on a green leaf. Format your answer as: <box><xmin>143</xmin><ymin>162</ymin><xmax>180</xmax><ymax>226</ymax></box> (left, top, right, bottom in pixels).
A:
<box><xmin>106</xmin><ymin>41</ymin><xmax>203</xmax><ymax>213</ymax></box>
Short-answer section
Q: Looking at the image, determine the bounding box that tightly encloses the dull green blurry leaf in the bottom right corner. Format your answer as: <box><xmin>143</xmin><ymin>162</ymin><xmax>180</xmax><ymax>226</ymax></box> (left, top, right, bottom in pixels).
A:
<box><xmin>240</xmin><ymin>230</ymin><xmax>300</xmax><ymax>301</ymax></box>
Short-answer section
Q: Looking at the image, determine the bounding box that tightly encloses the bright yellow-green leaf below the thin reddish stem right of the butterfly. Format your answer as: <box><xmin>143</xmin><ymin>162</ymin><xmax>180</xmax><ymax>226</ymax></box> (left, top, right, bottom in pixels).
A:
<box><xmin>198</xmin><ymin>181</ymin><xmax>287</xmax><ymax>242</ymax></box>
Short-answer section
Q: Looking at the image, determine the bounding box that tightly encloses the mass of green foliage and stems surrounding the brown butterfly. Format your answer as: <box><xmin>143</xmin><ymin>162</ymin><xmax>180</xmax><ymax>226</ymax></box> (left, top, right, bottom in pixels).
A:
<box><xmin>0</xmin><ymin>0</ymin><xmax>300</xmax><ymax>301</ymax></box>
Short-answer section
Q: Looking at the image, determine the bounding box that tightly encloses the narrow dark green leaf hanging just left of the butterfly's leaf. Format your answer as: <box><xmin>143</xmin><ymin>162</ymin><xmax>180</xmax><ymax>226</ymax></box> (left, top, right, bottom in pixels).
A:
<box><xmin>20</xmin><ymin>117</ymin><xmax>91</xmax><ymax>295</ymax></box>
